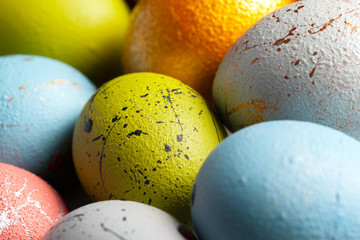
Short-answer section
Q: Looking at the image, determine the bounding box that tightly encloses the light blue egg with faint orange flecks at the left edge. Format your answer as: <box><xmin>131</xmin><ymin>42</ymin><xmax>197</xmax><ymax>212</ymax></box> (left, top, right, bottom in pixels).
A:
<box><xmin>0</xmin><ymin>55</ymin><xmax>96</xmax><ymax>181</ymax></box>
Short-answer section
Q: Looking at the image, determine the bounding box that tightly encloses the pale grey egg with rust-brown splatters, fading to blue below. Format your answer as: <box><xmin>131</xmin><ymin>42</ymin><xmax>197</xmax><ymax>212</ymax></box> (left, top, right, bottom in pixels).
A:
<box><xmin>213</xmin><ymin>0</ymin><xmax>360</xmax><ymax>140</ymax></box>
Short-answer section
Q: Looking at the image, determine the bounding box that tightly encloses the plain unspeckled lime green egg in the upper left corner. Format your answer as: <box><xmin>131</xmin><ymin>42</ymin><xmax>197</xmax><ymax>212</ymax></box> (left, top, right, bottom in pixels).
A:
<box><xmin>0</xmin><ymin>0</ymin><xmax>130</xmax><ymax>85</ymax></box>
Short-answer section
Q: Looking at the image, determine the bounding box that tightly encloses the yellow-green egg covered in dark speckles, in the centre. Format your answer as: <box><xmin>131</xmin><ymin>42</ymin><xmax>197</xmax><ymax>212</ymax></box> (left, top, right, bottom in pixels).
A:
<box><xmin>73</xmin><ymin>73</ymin><xmax>226</xmax><ymax>224</ymax></box>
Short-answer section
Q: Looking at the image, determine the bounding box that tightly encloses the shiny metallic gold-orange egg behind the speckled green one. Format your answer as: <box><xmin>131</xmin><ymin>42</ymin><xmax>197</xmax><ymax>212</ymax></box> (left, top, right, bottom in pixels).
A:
<box><xmin>123</xmin><ymin>0</ymin><xmax>295</xmax><ymax>101</ymax></box>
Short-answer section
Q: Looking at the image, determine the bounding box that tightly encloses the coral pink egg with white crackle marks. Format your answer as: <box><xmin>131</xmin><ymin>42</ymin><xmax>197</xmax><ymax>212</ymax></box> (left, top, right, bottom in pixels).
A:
<box><xmin>0</xmin><ymin>163</ymin><xmax>68</xmax><ymax>240</ymax></box>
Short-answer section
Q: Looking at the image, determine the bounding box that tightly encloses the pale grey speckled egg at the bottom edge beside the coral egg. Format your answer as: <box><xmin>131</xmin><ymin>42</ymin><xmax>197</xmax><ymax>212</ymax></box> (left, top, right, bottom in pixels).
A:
<box><xmin>42</xmin><ymin>200</ymin><xmax>200</xmax><ymax>240</ymax></box>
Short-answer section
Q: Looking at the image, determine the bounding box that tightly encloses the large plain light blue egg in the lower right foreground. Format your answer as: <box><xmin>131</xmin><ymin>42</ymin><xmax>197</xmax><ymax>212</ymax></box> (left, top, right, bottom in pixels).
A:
<box><xmin>191</xmin><ymin>120</ymin><xmax>360</xmax><ymax>240</ymax></box>
